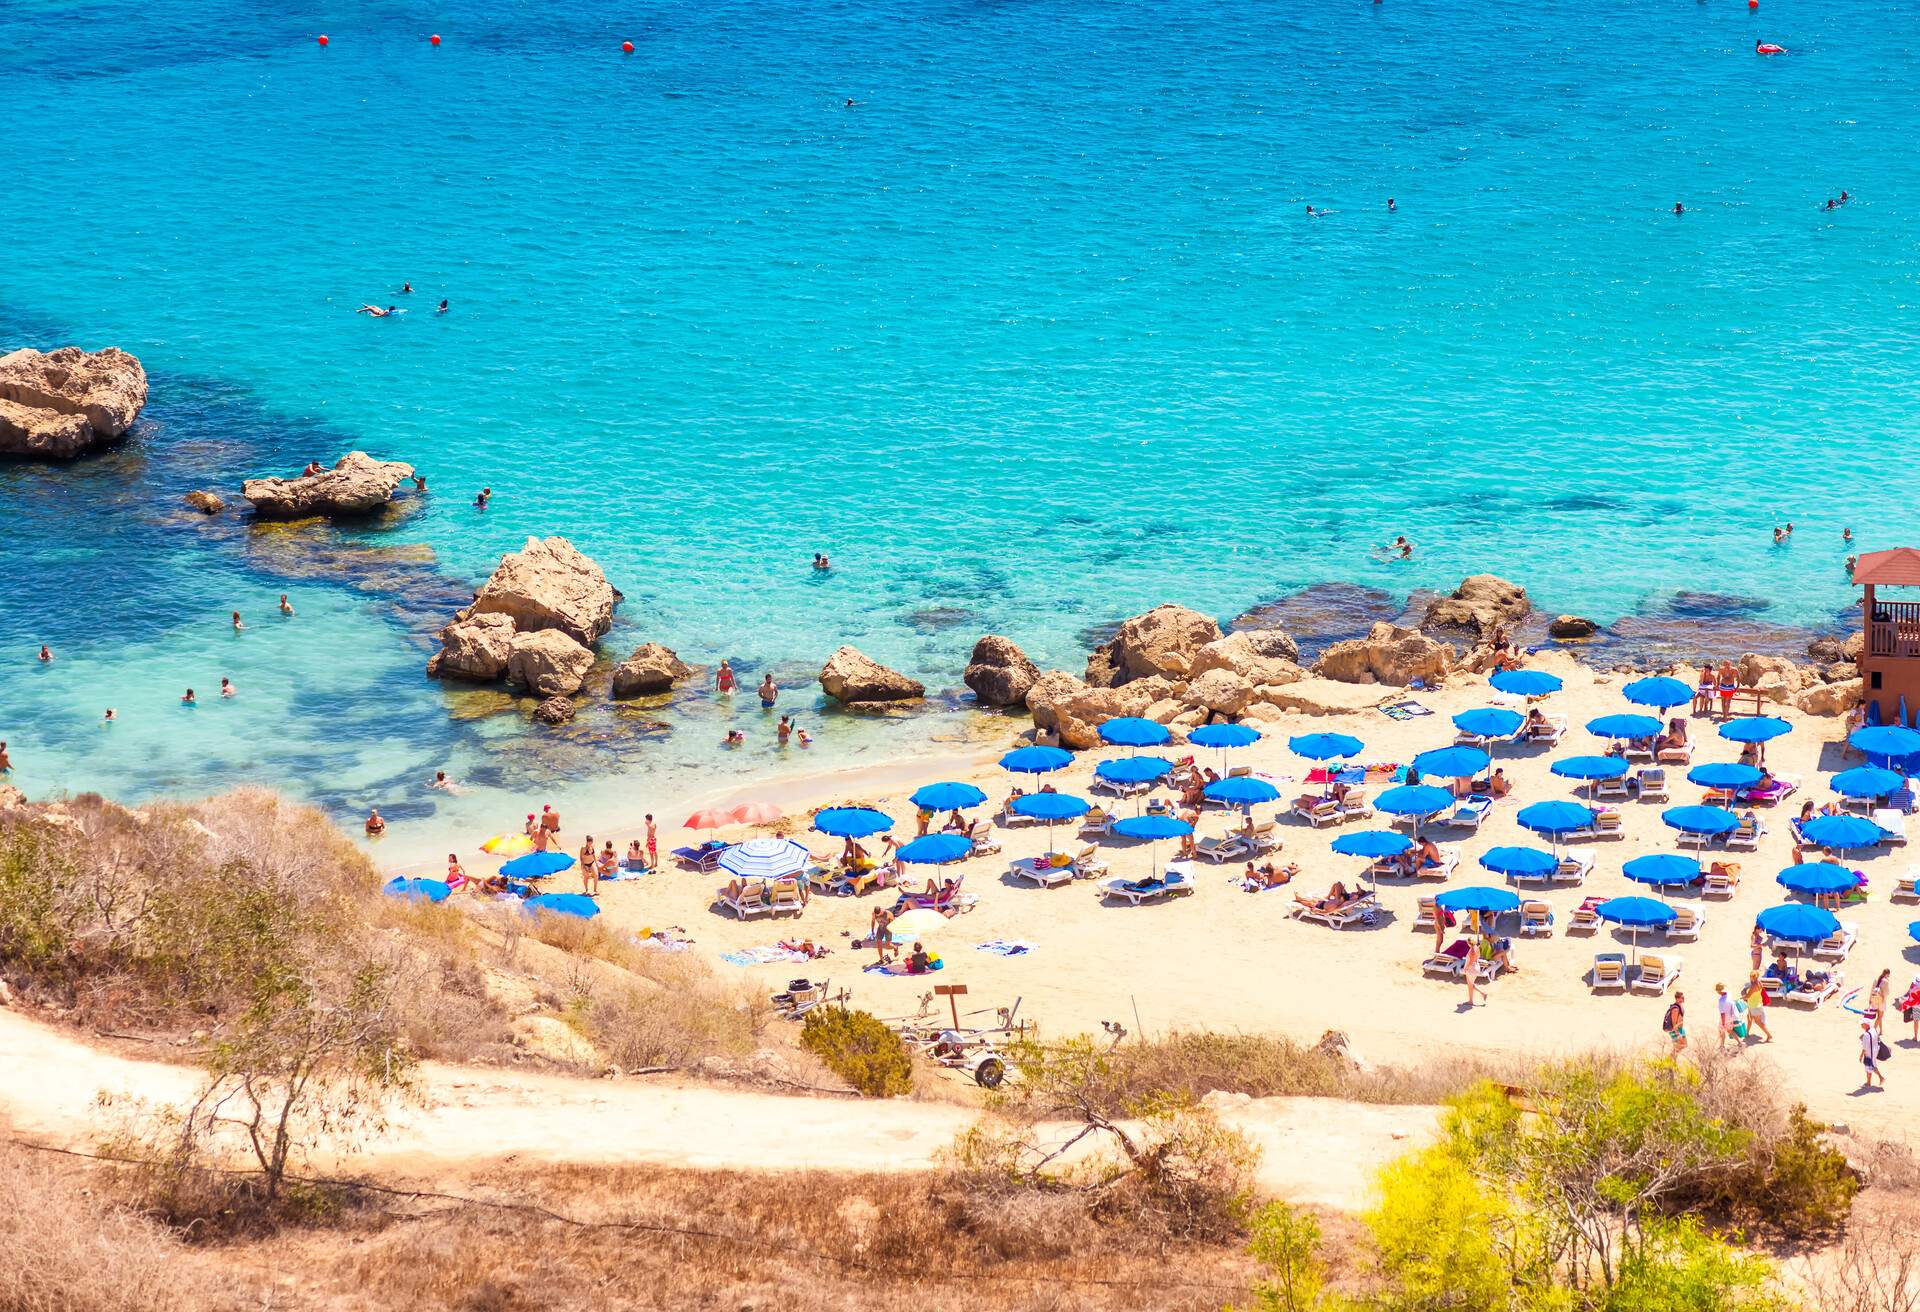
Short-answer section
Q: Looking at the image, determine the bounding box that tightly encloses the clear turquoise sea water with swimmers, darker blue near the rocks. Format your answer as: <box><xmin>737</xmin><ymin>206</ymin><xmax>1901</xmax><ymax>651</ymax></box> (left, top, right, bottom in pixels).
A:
<box><xmin>0</xmin><ymin>0</ymin><xmax>1920</xmax><ymax>837</ymax></box>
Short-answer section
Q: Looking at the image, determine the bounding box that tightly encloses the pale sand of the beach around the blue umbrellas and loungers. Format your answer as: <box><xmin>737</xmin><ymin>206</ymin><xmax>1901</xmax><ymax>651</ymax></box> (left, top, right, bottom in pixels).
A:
<box><xmin>389</xmin><ymin>653</ymin><xmax>1920</xmax><ymax>1133</ymax></box>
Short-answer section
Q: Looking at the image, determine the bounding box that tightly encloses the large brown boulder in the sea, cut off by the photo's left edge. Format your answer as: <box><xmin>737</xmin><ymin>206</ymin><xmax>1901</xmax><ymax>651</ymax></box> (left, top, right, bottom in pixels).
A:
<box><xmin>0</xmin><ymin>346</ymin><xmax>146</xmax><ymax>459</ymax></box>
